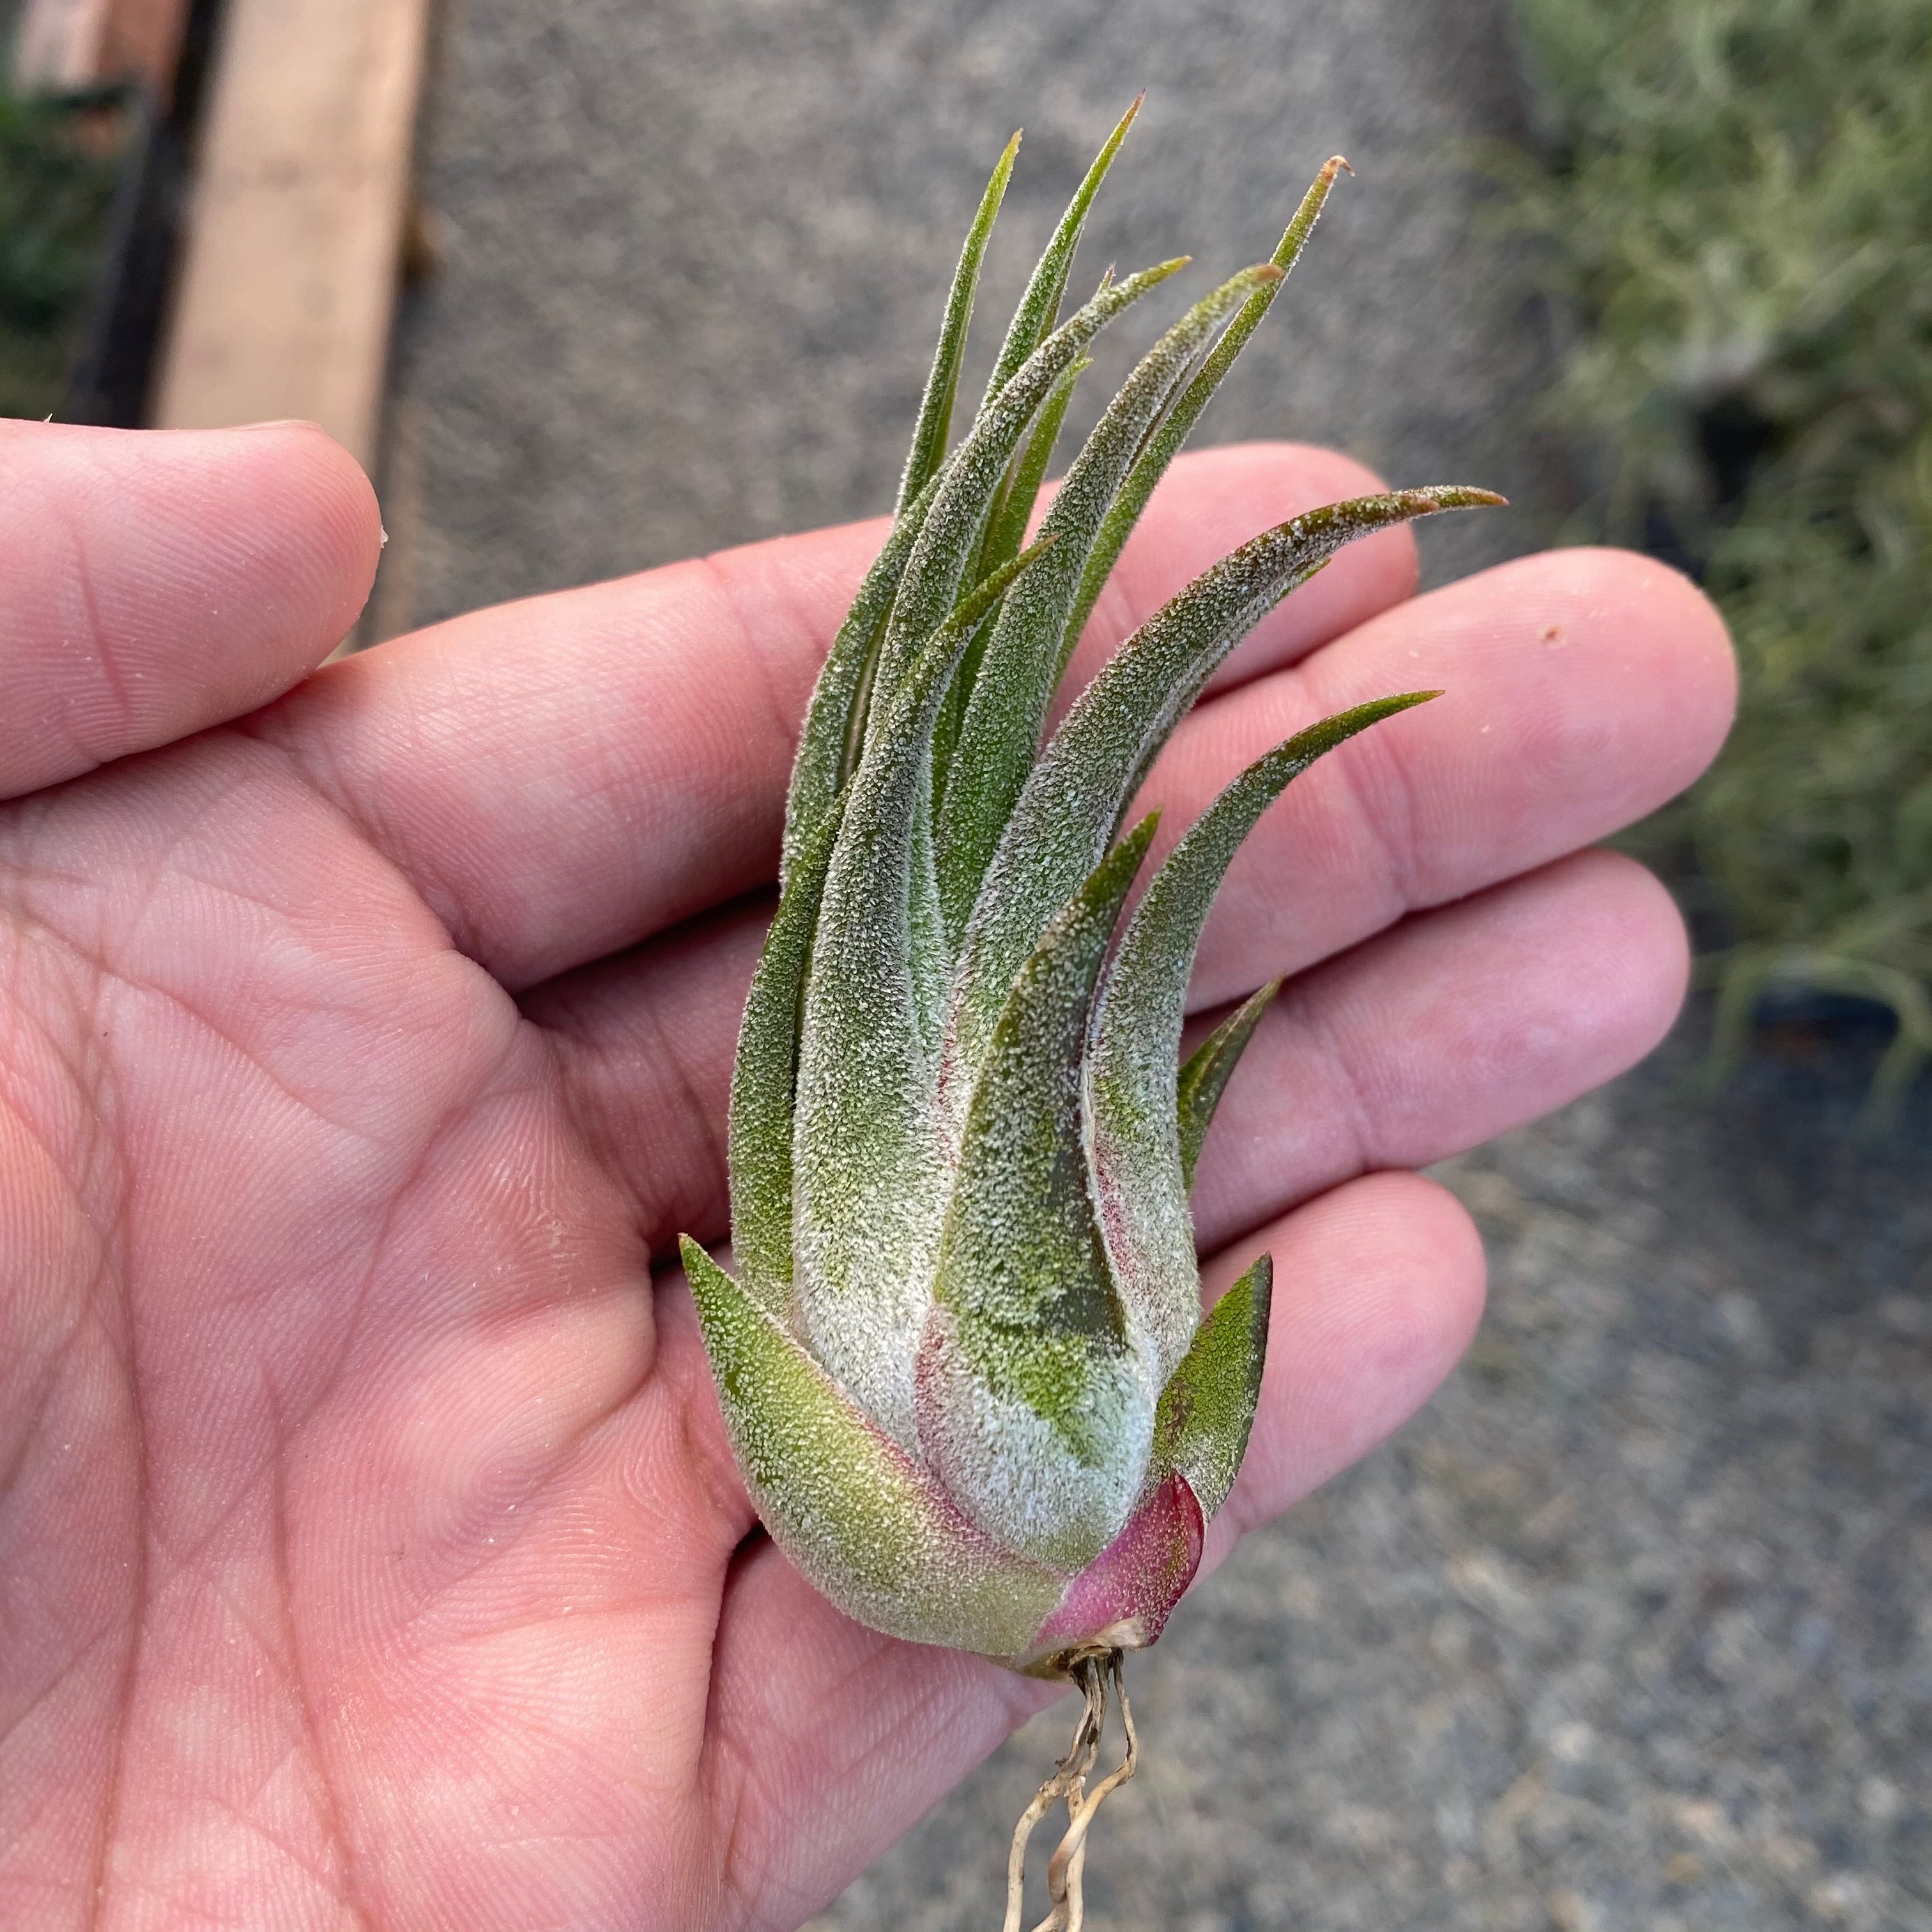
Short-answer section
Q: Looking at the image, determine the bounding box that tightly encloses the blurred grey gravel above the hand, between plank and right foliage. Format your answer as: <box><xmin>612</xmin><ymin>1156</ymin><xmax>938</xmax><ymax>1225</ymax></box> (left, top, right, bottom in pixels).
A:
<box><xmin>383</xmin><ymin>0</ymin><xmax>1547</xmax><ymax>630</ymax></box>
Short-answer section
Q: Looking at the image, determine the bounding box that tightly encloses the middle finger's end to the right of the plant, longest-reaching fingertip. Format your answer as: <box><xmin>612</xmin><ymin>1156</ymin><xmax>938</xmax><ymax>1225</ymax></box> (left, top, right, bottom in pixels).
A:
<box><xmin>1136</xmin><ymin>551</ymin><xmax>1737</xmax><ymax>1009</ymax></box>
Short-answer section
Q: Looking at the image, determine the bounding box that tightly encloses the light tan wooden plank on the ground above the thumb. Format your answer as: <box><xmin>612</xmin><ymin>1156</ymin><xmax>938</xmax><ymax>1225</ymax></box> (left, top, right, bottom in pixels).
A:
<box><xmin>155</xmin><ymin>0</ymin><xmax>429</xmax><ymax>468</ymax></box>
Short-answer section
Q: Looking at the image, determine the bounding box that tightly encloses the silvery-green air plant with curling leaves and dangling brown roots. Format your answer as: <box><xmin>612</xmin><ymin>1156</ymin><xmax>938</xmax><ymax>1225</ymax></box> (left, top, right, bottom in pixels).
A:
<box><xmin>684</xmin><ymin>102</ymin><xmax>1501</xmax><ymax>1928</ymax></box>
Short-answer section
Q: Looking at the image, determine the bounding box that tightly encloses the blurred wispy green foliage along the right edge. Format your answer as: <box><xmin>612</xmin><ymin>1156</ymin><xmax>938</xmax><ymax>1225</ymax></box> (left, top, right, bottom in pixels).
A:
<box><xmin>1507</xmin><ymin>0</ymin><xmax>1932</xmax><ymax>1098</ymax></box>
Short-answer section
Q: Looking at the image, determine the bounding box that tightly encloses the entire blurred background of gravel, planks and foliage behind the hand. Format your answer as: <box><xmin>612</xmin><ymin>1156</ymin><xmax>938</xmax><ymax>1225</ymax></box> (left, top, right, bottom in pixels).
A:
<box><xmin>11</xmin><ymin>0</ymin><xmax>1932</xmax><ymax>1932</ymax></box>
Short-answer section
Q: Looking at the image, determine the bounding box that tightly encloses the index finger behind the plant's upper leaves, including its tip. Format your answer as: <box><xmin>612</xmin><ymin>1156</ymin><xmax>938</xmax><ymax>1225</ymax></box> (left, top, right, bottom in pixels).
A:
<box><xmin>251</xmin><ymin>447</ymin><xmax>1414</xmax><ymax>987</ymax></box>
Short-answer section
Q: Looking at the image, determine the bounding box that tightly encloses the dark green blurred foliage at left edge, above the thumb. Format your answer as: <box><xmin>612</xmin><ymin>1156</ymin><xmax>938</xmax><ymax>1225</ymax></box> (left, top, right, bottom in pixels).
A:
<box><xmin>0</xmin><ymin>91</ymin><xmax>114</xmax><ymax>415</ymax></box>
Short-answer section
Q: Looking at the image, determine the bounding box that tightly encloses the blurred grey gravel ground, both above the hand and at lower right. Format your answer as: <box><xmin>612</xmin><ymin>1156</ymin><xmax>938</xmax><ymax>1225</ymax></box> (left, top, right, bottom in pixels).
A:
<box><xmin>379</xmin><ymin>0</ymin><xmax>1932</xmax><ymax>1932</ymax></box>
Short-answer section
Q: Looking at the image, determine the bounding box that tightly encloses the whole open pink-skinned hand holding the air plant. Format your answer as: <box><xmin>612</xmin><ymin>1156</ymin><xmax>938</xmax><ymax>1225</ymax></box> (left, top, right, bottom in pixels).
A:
<box><xmin>0</xmin><ymin>423</ymin><xmax>1733</xmax><ymax>1932</ymax></box>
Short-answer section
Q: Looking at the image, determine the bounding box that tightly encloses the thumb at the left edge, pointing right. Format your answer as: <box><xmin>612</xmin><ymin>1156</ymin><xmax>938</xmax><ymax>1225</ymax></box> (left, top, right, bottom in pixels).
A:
<box><xmin>0</xmin><ymin>423</ymin><xmax>383</xmax><ymax>796</ymax></box>
